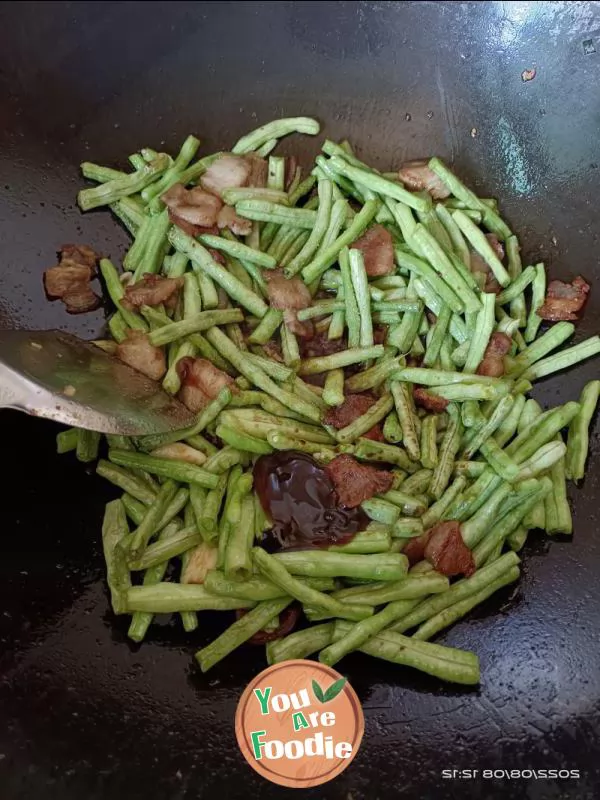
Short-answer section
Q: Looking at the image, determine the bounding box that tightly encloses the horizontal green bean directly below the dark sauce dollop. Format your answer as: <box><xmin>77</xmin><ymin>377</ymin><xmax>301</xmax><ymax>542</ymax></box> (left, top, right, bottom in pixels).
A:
<box><xmin>274</xmin><ymin>550</ymin><xmax>408</xmax><ymax>581</ymax></box>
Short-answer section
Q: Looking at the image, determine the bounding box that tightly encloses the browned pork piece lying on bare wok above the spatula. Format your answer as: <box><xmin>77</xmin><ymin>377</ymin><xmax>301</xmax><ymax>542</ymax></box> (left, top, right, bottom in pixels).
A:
<box><xmin>44</xmin><ymin>244</ymin><xmax>100</xmax><ymax>314</ymax></box>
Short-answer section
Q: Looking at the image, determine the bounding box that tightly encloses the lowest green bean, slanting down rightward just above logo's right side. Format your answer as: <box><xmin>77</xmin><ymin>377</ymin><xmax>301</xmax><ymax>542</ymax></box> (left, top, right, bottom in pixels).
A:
<box><xmin>334</xmin><ymin>620</ymin><xmax>480</xmax><ymax>684</ymax></box>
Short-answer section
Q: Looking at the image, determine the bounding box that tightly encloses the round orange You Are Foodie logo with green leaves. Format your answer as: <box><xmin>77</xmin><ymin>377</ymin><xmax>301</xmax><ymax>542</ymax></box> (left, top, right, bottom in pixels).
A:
<box><xmin>235</xmin><ymin>659</ymin><xmax>365</xmax><ymax>789</ymax></box>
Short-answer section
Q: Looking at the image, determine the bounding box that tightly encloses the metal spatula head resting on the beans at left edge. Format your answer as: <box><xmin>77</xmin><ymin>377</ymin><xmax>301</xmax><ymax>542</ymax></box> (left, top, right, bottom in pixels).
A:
<box><xmin>0</xmin><ymin>330</ymin><xmax>194</xmax><ymax>436</ymax></box>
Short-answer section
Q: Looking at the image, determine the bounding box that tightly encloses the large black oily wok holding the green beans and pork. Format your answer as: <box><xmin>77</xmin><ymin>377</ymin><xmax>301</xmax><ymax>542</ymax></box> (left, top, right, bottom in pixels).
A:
<box><xmin>0</xmin><ymin>2</ymin><xmax>600</xmax><ymax>800</ymax></box>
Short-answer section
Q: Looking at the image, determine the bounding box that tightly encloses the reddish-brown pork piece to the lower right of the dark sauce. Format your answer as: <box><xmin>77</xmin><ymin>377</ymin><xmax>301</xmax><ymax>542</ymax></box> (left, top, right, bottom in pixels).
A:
<box><xmin>402</xmin><ymin>520</ymin><xmax>475</xmax><ymax>578</ymax></box>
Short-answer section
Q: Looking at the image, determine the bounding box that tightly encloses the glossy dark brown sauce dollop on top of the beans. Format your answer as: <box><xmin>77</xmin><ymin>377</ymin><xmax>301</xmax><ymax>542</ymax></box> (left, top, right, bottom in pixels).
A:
<box><xmin>254</xmin><ymin>450</ymin><xmax>369</xmax><ymax>550</ymax></box>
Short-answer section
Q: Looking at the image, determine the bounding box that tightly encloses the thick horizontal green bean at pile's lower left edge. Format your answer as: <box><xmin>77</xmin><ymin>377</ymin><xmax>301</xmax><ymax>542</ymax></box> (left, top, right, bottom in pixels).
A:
<box><xmin>127</xmin><ymin>582</ymin><xmax>253</xmax><ymax>614</ymax></box>
